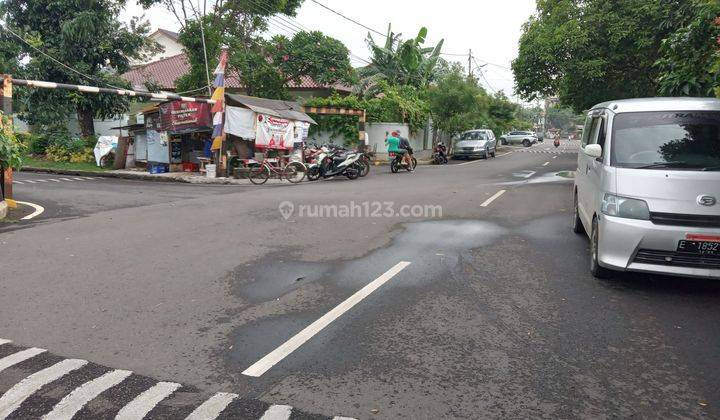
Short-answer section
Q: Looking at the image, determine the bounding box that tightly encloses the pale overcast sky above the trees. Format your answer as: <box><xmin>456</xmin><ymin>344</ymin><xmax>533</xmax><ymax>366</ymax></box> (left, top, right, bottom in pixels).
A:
<box><xmin>123</xmin><ymin>0</ymin><xmax>535</xmax><ymax>101</ymax></box>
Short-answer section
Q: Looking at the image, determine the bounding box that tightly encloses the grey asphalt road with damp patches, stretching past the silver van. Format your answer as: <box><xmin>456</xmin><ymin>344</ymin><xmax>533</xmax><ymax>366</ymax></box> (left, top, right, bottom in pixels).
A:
<box><xmin>0</xmin><ymin>143</ymin><xmax>720</xmax><ymax>419</ymax></box>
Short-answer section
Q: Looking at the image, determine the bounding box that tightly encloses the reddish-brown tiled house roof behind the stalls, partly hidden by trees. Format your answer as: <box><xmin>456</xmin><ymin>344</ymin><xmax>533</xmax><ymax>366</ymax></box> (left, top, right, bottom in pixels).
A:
<box><xmin>122</xmin><ymin>53</ymin><xmax>351</xmax><ymax>92</ymax></box>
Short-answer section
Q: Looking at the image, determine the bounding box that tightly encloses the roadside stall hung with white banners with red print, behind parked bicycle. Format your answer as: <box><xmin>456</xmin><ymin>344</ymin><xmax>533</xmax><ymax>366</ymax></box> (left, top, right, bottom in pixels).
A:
<box><xmin>224</xmin><ymin>94</ymin><xmax>315</xmax><ymax>174</ymax></box>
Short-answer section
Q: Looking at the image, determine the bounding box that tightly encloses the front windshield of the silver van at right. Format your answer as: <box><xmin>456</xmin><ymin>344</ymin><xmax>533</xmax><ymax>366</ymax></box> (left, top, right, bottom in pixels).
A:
<box><xmin>611</xmin><ymin>111</ymin><xmax>720</xmax><ymax>170</ymax></box>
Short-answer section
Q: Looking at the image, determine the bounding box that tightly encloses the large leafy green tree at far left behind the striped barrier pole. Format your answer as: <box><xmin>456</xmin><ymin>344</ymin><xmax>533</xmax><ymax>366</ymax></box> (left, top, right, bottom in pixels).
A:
<box><xmin>0</xmin><ymin>0</ymin><xmax>152</xmax><ymax>136</ymax></box>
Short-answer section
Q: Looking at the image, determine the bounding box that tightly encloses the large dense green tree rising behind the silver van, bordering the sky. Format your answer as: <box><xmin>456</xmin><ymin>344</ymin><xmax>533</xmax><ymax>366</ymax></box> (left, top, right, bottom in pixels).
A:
<box><xmin>512</xmin><ymin>0</ymin><xmax>695</xmax><ymax>112</ymax></box>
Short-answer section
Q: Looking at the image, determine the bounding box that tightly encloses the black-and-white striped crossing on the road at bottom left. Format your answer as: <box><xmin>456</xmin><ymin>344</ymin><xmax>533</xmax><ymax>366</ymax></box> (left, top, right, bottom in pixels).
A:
<box><xmin>0</xmin><ymin>338</ymin><xmax>352</xmax><ymax>420</ymax></box>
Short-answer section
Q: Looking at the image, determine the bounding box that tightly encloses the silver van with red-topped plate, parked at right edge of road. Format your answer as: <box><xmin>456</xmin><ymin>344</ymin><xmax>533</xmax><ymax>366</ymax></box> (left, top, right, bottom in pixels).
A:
<box><xmin>573</xmin><ymin>98</ymin><xmax>720</xmax><ymax>278</ymax></box>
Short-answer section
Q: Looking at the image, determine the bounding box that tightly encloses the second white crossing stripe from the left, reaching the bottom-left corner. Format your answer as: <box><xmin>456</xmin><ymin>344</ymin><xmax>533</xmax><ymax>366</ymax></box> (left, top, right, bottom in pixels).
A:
<box><xmin>0</xmin><ymin>359</ymin><xmax>87</xmax><ymax>419</ymax></box>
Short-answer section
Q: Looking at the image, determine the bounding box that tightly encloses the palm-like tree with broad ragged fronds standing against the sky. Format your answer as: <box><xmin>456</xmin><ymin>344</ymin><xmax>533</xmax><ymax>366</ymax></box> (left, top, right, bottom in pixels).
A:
<box><xmin>358</xmin><ymin>25</ymin><xmax>444</xmax><ymax>96</ymax></box>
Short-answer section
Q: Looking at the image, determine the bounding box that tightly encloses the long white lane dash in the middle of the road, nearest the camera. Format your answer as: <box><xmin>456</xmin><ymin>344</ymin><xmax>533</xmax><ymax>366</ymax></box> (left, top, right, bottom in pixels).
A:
<box><xmin>242</xmin><ymin>261</ymin><xmax>410</xmax><ymax>377</ymax></box>
